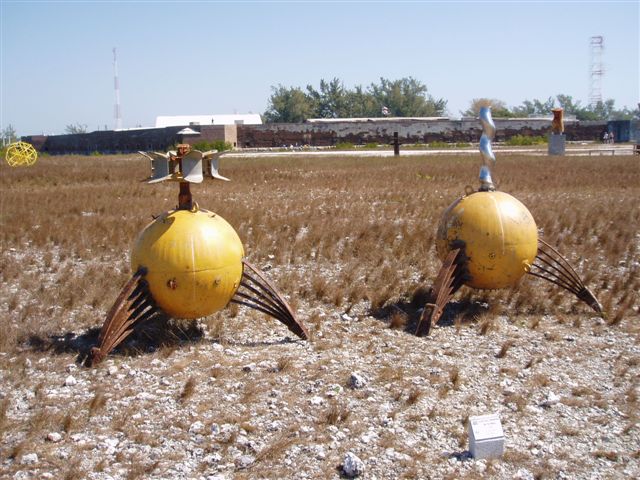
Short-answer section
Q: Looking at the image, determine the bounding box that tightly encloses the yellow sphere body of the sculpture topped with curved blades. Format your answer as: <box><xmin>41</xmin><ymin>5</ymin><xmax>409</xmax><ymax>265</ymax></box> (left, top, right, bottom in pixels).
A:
<box><xmin>131</xmin><ymin>208</ymin><xmax>244</xmax><ymax>319</ymax></box>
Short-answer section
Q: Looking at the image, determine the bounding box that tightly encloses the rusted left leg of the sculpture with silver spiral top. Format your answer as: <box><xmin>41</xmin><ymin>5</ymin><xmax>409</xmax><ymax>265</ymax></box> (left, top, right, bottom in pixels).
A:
<box><xmin>416</xmin><ymin>248</ymin><xmax>468</xmax><ymax>337</ymax></box>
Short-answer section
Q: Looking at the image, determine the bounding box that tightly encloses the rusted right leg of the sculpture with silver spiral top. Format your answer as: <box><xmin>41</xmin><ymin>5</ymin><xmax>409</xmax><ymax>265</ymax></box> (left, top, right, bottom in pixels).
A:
<box><xmin>529</xmin><ymin>238</ymin><xmax>603</xmax><ymax>313</ymax></box>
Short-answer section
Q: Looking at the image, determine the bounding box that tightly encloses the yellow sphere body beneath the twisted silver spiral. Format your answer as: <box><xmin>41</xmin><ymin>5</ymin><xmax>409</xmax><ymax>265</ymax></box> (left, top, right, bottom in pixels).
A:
<box><xmin>436</xmin><ymin>191</ymin><xmax>538</xmax><ymax>289</ymax></box>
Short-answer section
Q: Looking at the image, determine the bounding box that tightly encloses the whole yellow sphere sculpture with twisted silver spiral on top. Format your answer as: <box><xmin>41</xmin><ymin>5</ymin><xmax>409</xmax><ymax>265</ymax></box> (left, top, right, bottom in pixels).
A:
<box><xmin>416</xmin><ymin>106</ymin><xmax>602</xmax><ymax>336</ymax></box>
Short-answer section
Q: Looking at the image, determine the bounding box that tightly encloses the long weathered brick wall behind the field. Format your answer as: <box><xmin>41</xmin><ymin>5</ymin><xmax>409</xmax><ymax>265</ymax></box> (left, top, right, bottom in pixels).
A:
<box><xmin>22</xmin><ymin>118</ymin><xmax>607</xmax><ymax>154</ymax></box>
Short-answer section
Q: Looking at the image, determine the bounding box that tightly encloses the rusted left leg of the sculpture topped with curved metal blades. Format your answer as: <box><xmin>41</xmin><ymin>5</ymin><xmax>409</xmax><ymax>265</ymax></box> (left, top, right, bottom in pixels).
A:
<box><xmin>89</xmin><ymin>268</ymin><xmax>158</xmax><ymax>366</ymax></box>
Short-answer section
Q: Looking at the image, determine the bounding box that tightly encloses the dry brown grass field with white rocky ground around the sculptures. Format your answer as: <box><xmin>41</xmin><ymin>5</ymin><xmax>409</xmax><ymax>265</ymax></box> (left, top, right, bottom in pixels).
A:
<box><xmin>0</xmin><ymin>153</ymin><xmax>640</xmax><ymax>479</ymax></box>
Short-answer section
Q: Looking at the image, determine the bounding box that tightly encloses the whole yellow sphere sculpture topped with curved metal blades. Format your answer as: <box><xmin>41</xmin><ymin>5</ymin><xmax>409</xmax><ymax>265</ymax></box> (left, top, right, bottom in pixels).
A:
<box><xmin>89</xmin><ymin>145</ymin><xmax>308</xmax><ymax>365</ymax></box>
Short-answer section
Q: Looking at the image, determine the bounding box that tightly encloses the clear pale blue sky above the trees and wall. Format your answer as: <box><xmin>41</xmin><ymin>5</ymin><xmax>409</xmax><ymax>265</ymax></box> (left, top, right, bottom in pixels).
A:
<box><xmin>0</xmin><ymin>0</ymin><xmax>640</xmax><ymax>135</ymax></box>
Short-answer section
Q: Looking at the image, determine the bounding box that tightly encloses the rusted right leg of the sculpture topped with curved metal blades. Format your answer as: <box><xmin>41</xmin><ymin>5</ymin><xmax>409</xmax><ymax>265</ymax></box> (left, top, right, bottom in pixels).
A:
<box><xmin>231</xmin><ymin>260</ymin><xmax>309</xmax><ymax>340</ymax></box>
